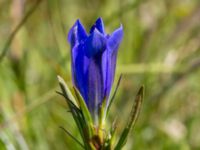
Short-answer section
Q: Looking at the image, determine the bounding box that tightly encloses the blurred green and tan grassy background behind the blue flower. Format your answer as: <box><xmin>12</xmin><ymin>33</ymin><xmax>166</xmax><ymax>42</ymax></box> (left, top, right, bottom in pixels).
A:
<box><xmin>0</xmin><ymin>0</ymin><xmax>200</xmax><ymax>150</ymax></box>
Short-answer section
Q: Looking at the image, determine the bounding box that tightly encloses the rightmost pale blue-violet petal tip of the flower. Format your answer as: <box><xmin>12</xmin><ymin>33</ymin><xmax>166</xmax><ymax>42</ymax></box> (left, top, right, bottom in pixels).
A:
<box><xmin>108</xmin><ymin>25</ymin><xmax>123</xmax><ymax>51</ymax></box>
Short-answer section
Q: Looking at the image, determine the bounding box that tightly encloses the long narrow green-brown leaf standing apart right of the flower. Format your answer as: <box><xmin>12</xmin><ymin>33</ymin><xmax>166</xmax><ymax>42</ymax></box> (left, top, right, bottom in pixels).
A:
<box><xmin>115</xmin><ymin>86</ymin><xmax>144</xmax><ymax>150</ymax></box>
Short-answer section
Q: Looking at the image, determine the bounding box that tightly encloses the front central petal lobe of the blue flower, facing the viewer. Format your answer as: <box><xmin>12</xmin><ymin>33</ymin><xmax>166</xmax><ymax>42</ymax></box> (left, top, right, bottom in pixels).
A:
<box><xmin>84</xmin><ymin>29</ymin><xmax>107</xmax><ymax>57</ymax></box>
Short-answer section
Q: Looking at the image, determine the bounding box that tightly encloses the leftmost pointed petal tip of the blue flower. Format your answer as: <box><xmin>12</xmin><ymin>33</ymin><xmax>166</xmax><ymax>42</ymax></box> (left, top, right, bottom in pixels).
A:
<box><xmin>68</xmin><ymin>20</ymin><xmax>87</xmax><ymax>48</ymax></box>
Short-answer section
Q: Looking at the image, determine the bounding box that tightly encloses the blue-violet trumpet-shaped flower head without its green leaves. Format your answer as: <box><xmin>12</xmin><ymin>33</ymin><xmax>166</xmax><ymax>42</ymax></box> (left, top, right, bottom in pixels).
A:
<box><xmin>68</xmin><ymin>18</ymin><xmax>123</xmax><ymax>117</ymax></box>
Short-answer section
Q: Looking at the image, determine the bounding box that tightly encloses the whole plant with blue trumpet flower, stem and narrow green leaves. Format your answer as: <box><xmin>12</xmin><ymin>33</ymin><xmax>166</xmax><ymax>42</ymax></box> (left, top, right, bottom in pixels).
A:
<box><xmin>58</xmin><ymin>18</ymin><xmax>143</xmax><ymax>150</ymax></box>
